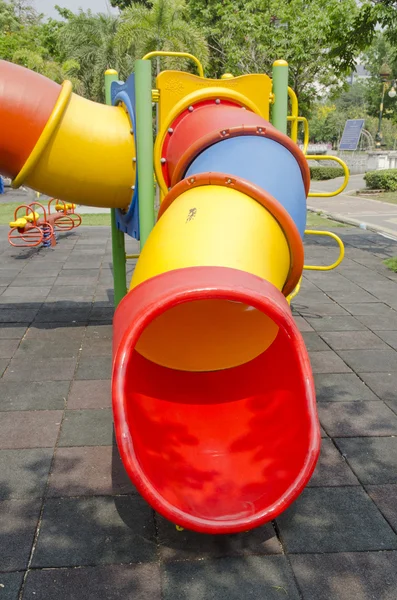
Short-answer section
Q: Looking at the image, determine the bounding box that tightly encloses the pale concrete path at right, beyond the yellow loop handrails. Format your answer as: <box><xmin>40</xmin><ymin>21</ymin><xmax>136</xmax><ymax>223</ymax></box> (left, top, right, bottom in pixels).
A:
<box><xmin>308</xmin><ymin>175</ymin><xmax>397</xmax><ymax>236</ymax></box>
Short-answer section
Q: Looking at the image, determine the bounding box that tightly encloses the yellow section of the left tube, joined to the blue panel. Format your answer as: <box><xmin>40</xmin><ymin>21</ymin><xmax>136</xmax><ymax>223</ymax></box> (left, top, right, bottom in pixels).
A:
<box><xmin>16</xmin><ymin>94</ymin><xmax>136</xmax><ymax>208</ymax></box>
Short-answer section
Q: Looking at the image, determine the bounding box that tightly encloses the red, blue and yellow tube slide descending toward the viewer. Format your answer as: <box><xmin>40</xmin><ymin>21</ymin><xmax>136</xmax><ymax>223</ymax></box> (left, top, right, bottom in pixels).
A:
<box><xmin>113</xmin><ymin>98</ymin><xmax>320</xmax><ymax>533</ymax></box>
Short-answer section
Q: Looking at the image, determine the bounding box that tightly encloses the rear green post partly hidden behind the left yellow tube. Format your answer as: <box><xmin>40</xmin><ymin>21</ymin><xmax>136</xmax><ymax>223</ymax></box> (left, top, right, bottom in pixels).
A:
<box><xmin>105</xmin><ymin>69</ymin><xmax>127</xmax><ymax>308</ymax></box>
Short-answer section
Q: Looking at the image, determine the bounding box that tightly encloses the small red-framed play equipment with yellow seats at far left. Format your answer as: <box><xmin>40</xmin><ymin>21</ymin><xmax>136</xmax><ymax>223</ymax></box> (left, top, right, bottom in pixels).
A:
<box><xmin>8</xmin><ymin>198</ymin><xmax>81</xmax><ymax>248</ymax></box>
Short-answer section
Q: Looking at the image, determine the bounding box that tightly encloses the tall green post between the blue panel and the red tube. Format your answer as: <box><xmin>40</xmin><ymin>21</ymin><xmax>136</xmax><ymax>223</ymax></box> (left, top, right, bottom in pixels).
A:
<box><xmin>135</xmin><ymin>60</ymin><xmax>154</xmax><ymax>251</ymax></box>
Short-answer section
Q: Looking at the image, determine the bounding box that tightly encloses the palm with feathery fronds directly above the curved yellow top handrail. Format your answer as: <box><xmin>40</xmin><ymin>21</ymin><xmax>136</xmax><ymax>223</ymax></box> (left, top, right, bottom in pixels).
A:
<box><xmin>117</xmin><ymin>0</ymin><xmax>208</xmax><ymax>72</ymax></box>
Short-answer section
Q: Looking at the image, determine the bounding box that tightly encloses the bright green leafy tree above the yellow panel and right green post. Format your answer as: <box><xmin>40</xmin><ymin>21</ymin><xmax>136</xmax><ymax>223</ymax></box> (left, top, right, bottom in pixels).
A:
<box><xmin>189</xmin><ymin>0</ymin><xmax>357</xmax><ymax>110</ymax></box>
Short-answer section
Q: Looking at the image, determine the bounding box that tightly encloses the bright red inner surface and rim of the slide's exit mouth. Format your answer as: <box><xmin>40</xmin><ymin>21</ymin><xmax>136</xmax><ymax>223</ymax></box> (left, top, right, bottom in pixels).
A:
<box><xmin>113</xmin><ymin>270</ymin><xmax>319</xmax><ymax>533</ymax></box>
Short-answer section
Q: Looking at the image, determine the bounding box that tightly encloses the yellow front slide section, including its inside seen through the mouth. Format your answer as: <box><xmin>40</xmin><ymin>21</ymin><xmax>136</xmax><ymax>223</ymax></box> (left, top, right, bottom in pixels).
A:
<box><xmin>131</xmin><ymin>185</ymin><xmax>291</xmax><ymax>371</ymax></box>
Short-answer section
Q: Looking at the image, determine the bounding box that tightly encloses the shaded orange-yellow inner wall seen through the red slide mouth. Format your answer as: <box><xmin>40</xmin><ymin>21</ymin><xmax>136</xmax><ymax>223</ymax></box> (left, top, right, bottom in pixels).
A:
<box><xmin>137</xmin><ymin>299</ymin><xmax>278</xmax><ymax>371</ymax></box>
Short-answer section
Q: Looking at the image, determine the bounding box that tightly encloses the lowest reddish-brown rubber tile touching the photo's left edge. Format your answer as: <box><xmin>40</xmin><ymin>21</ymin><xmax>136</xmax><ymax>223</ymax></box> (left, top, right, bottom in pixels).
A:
<box><xmin>0</xmin><ymin>410</ymin><xmax>62</xmax><ymax>449</ymax></box>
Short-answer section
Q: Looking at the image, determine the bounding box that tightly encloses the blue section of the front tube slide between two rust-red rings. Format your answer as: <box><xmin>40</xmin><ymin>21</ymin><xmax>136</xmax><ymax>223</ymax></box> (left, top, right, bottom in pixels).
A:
<box><xmin>185</xmin><ymin>136</ymin><xmax>306</xmax><ymax>238</ymax></box>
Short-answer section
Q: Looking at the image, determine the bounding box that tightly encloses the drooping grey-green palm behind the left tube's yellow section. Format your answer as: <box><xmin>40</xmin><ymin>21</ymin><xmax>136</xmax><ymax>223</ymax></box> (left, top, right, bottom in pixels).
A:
<box><xmin>59</xmin><ymin>10</ymin><xmax>134</xmax><ymax>101</ymax></box>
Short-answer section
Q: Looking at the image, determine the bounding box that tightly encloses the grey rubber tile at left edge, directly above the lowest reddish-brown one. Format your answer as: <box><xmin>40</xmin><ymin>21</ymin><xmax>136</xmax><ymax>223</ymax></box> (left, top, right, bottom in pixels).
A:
<box><xmin>0</xmin><ymin>380</ymin><xmax>70</xmax><ymax>412</ymax></box>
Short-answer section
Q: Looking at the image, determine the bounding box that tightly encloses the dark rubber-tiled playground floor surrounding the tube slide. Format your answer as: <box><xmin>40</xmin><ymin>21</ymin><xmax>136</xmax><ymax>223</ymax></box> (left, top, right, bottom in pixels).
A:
<box><xmin>0</xmin><ymin>227</ymin><xmax>397</xmax><ymax>600</ymax></box>
